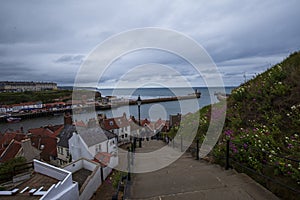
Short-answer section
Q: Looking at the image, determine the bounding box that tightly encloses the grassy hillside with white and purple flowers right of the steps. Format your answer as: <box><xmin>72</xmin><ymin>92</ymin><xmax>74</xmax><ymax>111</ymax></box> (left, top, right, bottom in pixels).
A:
<box><xmin>188</xmin><ymin>52</ymin><xmax>300</xmax><ymax>199</ymax></box>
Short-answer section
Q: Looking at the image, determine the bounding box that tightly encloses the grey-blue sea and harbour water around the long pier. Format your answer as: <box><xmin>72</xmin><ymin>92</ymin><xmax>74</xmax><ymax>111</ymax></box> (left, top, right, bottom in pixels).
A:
<box><xmin>0</xmin><ymin>87</ymin><xmax>235</xmax><ymax>133</ymax></box>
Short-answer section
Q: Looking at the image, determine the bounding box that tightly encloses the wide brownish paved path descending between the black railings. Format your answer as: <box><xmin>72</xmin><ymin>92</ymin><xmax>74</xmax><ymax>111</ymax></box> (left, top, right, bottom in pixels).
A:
<box><xmin>130</xmin><ymin>141</ymin><xmax>278</xmax><ymax>200</ymax></box>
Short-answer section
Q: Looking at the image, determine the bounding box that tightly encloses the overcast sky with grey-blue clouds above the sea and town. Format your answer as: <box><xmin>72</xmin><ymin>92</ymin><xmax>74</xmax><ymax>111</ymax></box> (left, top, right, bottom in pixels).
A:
<box><xmin>0</xmin><ymin>0</ymin><xmax>300</xmax><ymax>87</ymax></box>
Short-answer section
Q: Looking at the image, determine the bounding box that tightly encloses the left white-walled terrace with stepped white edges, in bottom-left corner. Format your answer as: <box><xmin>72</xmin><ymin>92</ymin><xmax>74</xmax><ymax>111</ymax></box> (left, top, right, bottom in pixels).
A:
<box><xmin>0</xmin><ymin>160</ymin><xmax>79</xmax><ymax>200</ymax></box>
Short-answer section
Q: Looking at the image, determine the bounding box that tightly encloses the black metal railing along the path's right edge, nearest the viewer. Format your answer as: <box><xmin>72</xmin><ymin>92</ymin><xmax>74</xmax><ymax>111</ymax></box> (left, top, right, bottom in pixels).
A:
<box><xmin>213</xmin><ymin>140</ymin><xmax>300</xmax><ymax>199</ymax></box>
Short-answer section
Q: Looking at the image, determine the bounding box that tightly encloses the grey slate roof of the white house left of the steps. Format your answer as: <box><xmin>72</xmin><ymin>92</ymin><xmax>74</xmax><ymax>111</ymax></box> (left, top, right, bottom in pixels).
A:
<box><xmin>77</xmin><ymin>127</ymin><xmax>116</xmax><ymax>147</ymax></box>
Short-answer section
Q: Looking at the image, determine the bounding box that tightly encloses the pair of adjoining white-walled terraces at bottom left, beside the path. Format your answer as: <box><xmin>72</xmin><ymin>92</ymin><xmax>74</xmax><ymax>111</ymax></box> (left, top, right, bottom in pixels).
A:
<box><xmin>0</xmin><ymin>158</ymin><xmax>108</xmax><ymax>200</ymax></box>
